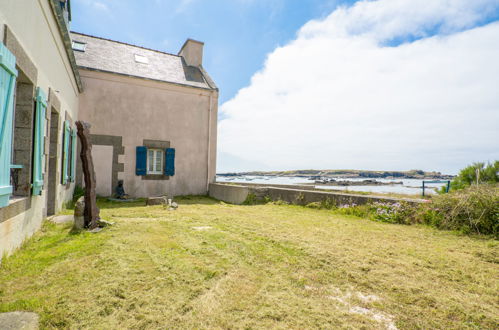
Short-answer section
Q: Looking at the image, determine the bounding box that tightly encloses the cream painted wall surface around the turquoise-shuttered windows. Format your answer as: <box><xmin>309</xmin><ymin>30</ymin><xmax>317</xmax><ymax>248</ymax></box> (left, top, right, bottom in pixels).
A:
<box><xmin>0</xmin><ymin>0</ymin><xmax>79</xmax><ymax>259</ymax></box>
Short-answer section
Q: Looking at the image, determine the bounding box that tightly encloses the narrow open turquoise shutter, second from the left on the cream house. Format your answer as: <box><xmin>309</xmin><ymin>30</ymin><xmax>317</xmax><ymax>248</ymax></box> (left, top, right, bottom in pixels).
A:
<box><xmin>33</xmin><ymin>87</ymin><xmax>47</xmax><ymax>195</ymax></box>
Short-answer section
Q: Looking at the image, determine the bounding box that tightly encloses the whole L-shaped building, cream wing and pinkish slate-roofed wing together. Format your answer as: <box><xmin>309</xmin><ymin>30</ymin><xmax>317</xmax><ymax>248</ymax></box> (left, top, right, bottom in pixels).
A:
<box><xmin>0</xmin><ymin>0</ymin><xmax>218</xmax><ymax>259</ymax></box>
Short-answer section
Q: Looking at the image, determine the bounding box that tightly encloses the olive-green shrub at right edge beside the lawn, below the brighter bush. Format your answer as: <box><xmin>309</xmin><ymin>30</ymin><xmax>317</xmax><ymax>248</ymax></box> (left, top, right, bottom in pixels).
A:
<box><xmin>419</xmin><ymin>184</ymin><xmax>499</xmax><ymax>237</ymax></box>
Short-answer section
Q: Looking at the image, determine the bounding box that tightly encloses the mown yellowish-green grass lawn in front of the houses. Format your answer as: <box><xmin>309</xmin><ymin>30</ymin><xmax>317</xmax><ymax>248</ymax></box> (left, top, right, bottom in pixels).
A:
<box><xmin>0</xmin><ymin>198</ymin><xmax>499</xmax><ymax>329</ymax></box>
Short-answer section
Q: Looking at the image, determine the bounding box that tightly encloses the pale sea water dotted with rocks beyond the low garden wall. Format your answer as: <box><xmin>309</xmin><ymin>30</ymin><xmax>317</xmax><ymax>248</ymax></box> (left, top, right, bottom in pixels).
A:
<box><xmin>217</xmin><ymin>175</ymin><xmax>446</xmax><ymax>195</ymax></box>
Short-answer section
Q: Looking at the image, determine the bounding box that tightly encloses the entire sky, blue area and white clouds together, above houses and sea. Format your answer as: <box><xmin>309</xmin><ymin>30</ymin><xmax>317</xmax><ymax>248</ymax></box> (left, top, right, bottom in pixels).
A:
<box><xmin>72</xmin><ymin>0</ymin><xmax>499</xmax><ymax>174</ymax></box>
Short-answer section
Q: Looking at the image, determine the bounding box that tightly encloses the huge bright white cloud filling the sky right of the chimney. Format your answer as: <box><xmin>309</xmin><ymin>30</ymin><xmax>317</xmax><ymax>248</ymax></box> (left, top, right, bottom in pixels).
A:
<box><xmin>219</xmin><ymin>0</ymin><xmax>499</xmax><ymax>171</ymax></box>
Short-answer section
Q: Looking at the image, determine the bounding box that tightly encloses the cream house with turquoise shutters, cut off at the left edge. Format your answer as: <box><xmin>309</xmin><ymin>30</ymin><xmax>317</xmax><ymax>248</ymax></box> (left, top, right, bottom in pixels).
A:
<box><xmin>0</xmin><ymin>0</ymin><xmax>82</xmax><ymax>259</ymax></box>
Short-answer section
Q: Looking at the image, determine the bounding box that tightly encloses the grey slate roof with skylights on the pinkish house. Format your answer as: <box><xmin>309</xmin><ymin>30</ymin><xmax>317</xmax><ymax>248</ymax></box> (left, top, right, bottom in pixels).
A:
<box><xmin>71</xmin><ymin>32</ymin><xmax>216</xmax><ymax>89</ymax></box>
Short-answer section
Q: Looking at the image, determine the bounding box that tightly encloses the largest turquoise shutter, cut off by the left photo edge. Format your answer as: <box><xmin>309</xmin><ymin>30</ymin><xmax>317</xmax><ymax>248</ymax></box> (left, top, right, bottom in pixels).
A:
<box><xmin>0</xmin><ymin>43</ymin><xmax>17</xmax><ymax>207</ymax></box>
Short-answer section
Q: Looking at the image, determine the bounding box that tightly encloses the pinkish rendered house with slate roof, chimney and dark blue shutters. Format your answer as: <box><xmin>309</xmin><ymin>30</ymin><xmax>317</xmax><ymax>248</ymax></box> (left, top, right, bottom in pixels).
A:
<box><xmin>71</xmin><ymin>33</ymin><xmax>218</xmax><ymax>197</ymax></box>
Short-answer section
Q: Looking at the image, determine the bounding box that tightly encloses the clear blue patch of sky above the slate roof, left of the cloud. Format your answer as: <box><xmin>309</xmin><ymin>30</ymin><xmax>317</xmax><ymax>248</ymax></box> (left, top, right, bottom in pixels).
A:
<box><xmin>71</xmin><ymin>0</ymin><xmax>353</xmax><ymax>103</ymax></box>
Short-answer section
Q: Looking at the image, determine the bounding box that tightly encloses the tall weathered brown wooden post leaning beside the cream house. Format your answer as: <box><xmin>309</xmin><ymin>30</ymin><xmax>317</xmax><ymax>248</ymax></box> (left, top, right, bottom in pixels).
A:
<box><xmin>76</xmin><ymin>121</ymin><xmax>99</xmax><ymax>229</ymax></box>
